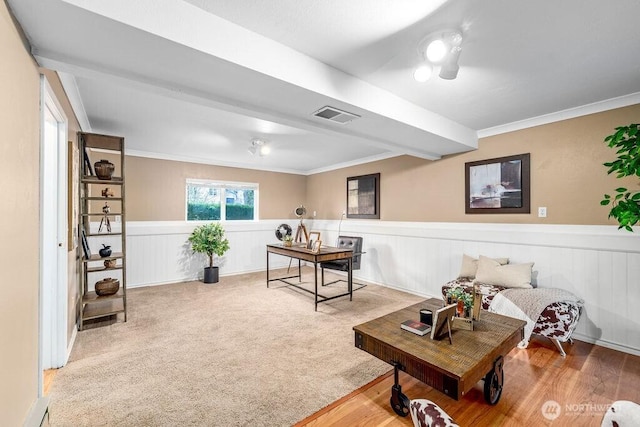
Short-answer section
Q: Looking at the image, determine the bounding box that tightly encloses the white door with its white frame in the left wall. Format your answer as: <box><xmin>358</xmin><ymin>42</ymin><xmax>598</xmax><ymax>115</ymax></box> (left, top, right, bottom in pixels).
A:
<box><xmin>39</xmin><ymin>76</ymin><xmax>68</xmax><ymax>382</ymax></box>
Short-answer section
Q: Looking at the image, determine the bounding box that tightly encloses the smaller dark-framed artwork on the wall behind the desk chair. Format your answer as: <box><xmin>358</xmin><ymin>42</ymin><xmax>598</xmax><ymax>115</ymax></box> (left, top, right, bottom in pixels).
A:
<box><xmin>347</xmin><ymin>173</ymin><xmax>380</xmax><ymax>219</ymax></box>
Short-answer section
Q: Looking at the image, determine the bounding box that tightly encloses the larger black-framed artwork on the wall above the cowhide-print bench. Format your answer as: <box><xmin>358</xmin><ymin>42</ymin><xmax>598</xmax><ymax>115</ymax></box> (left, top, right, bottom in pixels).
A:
<box><xmin>465</xmin><ymin>153</ymin><xmax>531</xmax><ymax>214</ymax></box>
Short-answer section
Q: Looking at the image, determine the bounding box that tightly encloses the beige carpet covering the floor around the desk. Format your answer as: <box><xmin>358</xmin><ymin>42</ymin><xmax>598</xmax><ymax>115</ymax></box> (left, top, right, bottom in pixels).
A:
<box><xmin>50</xmin><ymin>269</ymin><xmax>421</xmax><ymax>426</ymax></box>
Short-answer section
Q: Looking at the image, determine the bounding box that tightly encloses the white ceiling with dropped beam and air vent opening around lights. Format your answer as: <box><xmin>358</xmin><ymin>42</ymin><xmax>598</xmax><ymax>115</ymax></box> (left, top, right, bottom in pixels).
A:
<box><xmin>8</xmin><ymin>0</ymin><xmax>640</xmax><ymax>174</ymax></box>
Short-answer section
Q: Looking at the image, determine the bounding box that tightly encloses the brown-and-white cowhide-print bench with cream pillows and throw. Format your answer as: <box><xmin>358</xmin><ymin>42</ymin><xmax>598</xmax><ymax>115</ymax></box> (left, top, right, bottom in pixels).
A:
<box><xmin>442</xmin><ymin>255</ymin><xmax>582</xmax><ymax>357</ymax></box>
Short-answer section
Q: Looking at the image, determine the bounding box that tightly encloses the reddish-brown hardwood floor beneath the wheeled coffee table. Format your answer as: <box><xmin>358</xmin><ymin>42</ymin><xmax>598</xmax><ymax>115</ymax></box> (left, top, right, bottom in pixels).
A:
<box><xmin>296</xmin><ymin>337</ymin><xmax>640</xmax><ymax>427</ymax></box>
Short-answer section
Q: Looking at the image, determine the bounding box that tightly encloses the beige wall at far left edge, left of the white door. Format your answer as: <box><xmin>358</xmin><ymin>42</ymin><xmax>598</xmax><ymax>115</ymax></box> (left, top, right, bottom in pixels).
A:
<box><xmin>0</xmin><ymin>2</ymin><xmax>40</xmax><ymax>426</ymax></box>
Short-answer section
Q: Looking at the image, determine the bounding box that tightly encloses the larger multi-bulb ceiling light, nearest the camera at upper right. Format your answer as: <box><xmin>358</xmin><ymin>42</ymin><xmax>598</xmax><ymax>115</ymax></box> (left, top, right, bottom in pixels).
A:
<box><xmin>413</xmin><ymin>30</ymin><xmax>462</xmax><ymax>82</ymax></box>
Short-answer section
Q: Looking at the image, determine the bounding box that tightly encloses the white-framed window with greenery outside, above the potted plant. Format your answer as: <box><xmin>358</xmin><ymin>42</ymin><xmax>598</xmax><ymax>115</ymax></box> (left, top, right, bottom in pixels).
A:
<box><xmin>186</xmin><ymin>179</ymin><xmax>258</xmax><ymax>221</ymax></box>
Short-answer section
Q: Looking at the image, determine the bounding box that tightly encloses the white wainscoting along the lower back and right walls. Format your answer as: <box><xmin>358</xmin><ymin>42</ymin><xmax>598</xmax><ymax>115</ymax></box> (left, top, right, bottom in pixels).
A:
<box><xmin>127</xmin><ymin>219</ymin><xmax>640</xmax><ymax>354</ymax></box>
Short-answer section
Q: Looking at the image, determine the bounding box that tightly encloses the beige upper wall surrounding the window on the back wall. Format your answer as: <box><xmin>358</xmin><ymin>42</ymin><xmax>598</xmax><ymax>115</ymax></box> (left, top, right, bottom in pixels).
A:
<box><xmin>125</xmin><ymin>156</ymin><xmax>306</xmax><ymax>221</ymax></box>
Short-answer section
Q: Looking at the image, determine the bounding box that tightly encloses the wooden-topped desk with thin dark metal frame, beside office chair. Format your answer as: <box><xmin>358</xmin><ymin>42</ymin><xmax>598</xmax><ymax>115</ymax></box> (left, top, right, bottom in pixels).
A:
<box><xmin>267</xmin><ymin>244</ymin><xmax>353</xmax><ymax>311</ymax></box>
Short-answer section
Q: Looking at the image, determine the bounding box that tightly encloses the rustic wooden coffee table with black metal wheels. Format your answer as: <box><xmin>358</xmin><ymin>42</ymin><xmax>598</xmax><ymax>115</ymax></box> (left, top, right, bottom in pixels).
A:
<box><xmin>353</xmin><ymin>298</ymin><xmax>526</xmax><ymax>416</ymax></box>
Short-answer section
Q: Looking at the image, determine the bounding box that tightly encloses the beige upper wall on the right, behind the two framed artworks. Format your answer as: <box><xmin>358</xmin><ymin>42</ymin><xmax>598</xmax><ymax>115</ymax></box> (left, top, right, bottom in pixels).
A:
<box><xmin>306</xmin><ymin>105</ymin><xmax>640</xmax><ymax>225</ymax></box>
